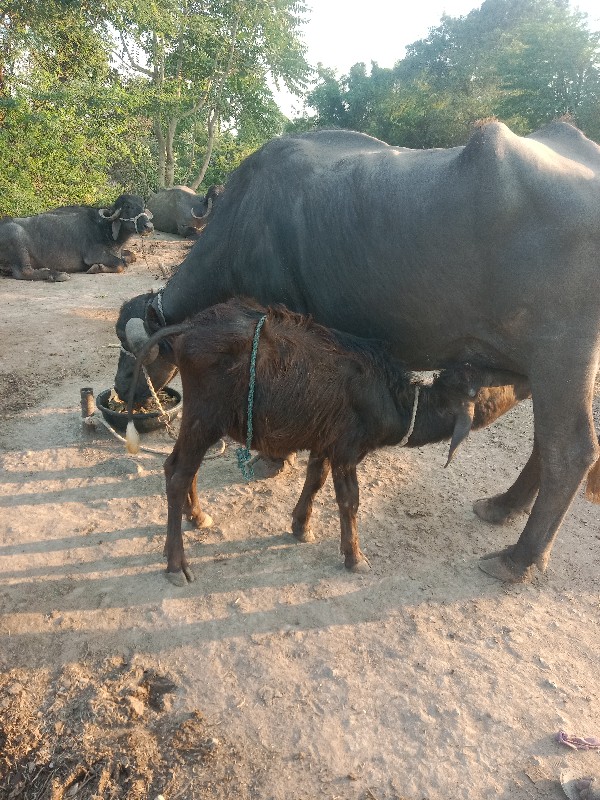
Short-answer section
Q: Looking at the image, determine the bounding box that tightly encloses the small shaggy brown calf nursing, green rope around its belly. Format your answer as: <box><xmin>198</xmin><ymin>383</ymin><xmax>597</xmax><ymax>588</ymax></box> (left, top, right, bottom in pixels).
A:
<box><xmin>128</xmin><ymin>299</ymin><xmax>528</xmax><ymax>586</ymax></box>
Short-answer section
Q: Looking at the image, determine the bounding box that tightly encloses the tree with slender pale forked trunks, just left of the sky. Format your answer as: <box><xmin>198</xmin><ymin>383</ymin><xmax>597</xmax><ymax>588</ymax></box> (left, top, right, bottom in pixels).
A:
<box><xmin>113</xmin><ymin>0</ymin><xmax>308</xmax><ymax>188</ymax></box>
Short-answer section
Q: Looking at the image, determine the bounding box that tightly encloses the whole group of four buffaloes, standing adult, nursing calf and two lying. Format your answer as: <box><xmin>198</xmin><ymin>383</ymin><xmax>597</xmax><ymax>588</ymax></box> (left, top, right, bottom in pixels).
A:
<box><xmin>0</xmin><ymin>121</ymin><xmax>600</xmax><ymax>585</ymax></box>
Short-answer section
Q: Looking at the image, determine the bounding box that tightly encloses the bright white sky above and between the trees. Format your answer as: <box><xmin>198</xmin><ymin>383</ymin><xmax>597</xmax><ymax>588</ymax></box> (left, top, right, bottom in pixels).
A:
<box><xmin>276</xmin><ymin>0</ymin><xmax>600</xmax><ymax>115</ymax></box>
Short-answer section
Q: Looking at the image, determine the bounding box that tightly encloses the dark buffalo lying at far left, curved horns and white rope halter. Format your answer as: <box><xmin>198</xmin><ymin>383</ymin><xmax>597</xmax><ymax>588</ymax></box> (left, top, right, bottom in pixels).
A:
<box><xmin>0</xmin><ymin>194</ymin><xmax>154</xmax><ymax>281</ymax></box>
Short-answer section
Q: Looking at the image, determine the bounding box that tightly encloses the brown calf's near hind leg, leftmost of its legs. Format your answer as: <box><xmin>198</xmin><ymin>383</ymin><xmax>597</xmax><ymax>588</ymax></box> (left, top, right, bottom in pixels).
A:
<box><xmin>164</xmin><ymin>440</ymin><xmax>208</xmax><ymax>586</ymax></box>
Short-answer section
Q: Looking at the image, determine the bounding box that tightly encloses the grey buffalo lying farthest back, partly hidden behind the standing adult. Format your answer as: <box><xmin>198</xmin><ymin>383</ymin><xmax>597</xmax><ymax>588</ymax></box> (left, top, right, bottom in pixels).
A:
<box><xmin>148</xmin><ymin>186</ymin><xmax>223</xmax><ymax>236</ymax></box>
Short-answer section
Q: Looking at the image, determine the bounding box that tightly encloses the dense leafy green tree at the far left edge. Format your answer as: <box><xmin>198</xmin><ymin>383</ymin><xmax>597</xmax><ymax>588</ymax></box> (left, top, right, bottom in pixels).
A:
<box><xmin>0</xmin><ymin>0</ymin><xmax>149</xmax><ymax>214</ymax></box>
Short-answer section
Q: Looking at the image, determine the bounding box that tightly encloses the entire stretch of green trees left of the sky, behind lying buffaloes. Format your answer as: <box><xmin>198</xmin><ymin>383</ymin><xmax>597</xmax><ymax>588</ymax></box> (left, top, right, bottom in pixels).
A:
<box><xmin>0</xmin><ymin>0</ymin><xmax>308</xmax><ymax>214</ymax></box>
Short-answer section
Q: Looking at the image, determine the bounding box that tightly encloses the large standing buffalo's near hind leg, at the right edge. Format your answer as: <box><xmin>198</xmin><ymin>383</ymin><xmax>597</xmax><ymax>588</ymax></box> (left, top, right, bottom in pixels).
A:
<box><xmin>480</xmin><ymin>360</ymin><xmax>598</xmax><ymax>583</ymax></box>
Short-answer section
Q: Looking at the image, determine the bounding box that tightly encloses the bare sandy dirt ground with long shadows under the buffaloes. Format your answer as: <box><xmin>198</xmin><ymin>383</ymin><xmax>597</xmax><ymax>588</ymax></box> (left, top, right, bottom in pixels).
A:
<box><xmin>0</xmin><ymin>235</ymin><xmax>600</xmax><ymax>800</ymax></box>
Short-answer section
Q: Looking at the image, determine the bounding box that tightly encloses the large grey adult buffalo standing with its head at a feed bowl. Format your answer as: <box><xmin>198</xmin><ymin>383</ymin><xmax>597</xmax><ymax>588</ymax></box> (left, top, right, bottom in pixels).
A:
<box><xmin>115</xmin><ymin>122</ymin><xmax>600</xmax><ymax>582</ymax></box>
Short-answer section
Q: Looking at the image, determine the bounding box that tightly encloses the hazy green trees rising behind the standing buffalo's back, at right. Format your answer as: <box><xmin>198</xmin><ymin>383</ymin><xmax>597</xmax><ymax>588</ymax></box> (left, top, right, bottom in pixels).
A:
<box><xmin>294</xmin><ymin>0</ymin><xmax>600</xmax><ymax>147</ymax></box>
